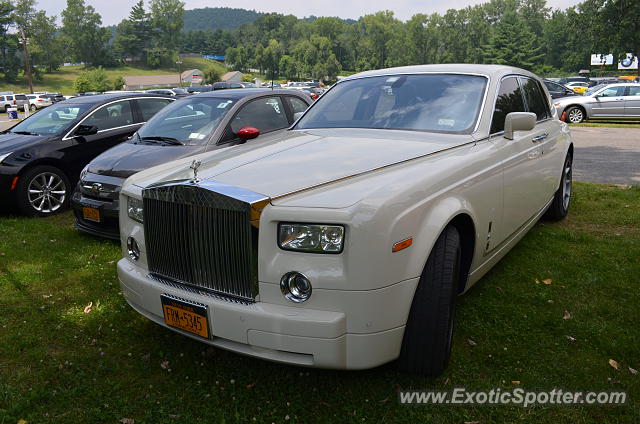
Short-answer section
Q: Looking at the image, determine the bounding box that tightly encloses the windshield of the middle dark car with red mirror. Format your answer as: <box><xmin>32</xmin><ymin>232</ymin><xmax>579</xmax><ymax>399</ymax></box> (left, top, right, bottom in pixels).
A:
<box><xmin>132</xmin><ymin>96</ymin><xmax>235</xmax><ymax>145</ymax></box>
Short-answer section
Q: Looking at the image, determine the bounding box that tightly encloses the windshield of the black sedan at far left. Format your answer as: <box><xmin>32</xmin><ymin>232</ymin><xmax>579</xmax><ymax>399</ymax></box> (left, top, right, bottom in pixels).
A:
<box><xmin>10</xmin><ymin>103</ymin><xmax>92</xmax><ymax>135</ymax></box>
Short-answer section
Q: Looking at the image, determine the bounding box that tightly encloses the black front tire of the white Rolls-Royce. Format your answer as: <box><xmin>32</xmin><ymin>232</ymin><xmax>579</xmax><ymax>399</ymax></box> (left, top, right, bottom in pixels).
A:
<box><xmin>398</xmin><ymin>226</ymin><xmax>461</xmax><ymax>376</ymax></box>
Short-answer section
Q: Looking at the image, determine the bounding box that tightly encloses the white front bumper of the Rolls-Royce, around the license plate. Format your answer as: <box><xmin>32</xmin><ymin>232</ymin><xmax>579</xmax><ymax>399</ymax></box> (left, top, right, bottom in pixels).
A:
<box><xmin>118</xmin><ymin>259</ymin><xmax>410</xmax><ymax>369</ymax></box>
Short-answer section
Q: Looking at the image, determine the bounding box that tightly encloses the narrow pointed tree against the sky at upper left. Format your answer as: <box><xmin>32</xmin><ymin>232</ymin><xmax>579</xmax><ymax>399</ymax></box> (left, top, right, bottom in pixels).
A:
<box><xmin>114</xmin><ymin>0</ymin><xmax>154</xmax><ymax>62</ymax></box>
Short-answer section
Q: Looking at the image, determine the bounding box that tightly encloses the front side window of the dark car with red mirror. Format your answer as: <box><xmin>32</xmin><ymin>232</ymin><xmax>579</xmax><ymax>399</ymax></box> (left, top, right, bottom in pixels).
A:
<box><xmin>230</xmin><ymin>97</ymin><xmax>289</xmax><ymax>134</ymax></box>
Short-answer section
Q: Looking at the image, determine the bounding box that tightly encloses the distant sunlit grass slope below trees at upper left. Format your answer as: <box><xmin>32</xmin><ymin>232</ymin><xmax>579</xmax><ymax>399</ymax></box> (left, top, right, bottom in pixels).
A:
<box><xmin>0</xmin><ymin>58</ymin><xmax>227</xmax><ymax>94</ymax></box>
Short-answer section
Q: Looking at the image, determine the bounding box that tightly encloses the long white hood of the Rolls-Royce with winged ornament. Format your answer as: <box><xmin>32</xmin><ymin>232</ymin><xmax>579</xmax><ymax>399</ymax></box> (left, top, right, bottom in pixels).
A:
<box><xmin>131</xmin><ymin>129</ymin><xmax>473</xmax><ymax>198</ymax></box>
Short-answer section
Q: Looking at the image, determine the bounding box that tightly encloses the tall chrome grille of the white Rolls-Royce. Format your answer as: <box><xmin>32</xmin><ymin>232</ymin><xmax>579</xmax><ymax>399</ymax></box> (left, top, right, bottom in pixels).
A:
<box><xmin>143</xmin><ymin>182</ymin><xmax>264</xmax><ymax>302</ymax></box>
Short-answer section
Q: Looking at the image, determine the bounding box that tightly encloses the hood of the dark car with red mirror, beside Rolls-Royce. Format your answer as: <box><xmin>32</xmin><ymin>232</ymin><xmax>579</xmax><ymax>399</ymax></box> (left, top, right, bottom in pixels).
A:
<box><xmin>87</xmin><ymin>143</ymin><xmax>205</xmax><ymax>178</ymax></box>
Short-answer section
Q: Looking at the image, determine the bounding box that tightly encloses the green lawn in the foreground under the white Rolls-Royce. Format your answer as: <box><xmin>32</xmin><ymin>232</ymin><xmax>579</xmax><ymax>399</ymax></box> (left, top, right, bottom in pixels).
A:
<box><xmin>0</xmin><ymin>183</ymin><xmax>640</xmax><ymax>424</ymax></box>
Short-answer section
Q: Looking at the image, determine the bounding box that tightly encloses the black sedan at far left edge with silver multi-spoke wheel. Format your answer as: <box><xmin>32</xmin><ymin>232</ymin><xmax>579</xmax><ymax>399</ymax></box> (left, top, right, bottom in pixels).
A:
<box><xmin>0</xmin><ymin>94</ymin><xmax>172</xmax><ymax>216</ymax></box>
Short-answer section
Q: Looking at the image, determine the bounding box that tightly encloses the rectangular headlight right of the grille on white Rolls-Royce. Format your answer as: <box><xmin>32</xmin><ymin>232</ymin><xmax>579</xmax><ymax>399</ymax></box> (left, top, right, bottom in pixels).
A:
<box><xmin>278</xmin><ymin>223</ymin><xmax>344</xmax><ymax>253</ymax></box>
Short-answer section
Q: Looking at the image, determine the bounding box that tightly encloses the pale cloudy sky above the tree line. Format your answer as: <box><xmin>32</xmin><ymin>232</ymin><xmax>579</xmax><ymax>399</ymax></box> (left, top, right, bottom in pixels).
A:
<box><xmin>36</xmin><ymin>0</ymin><xmax>581</xmax><ymax>25</ymax></box>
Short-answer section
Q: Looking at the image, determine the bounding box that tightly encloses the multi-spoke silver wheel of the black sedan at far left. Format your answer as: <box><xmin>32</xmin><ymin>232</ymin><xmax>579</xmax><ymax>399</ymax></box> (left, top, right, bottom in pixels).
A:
<box><xmin>17</xmin><ymin>166</ymin><xmax>70</xmax><ymax>216</ymax></box>
